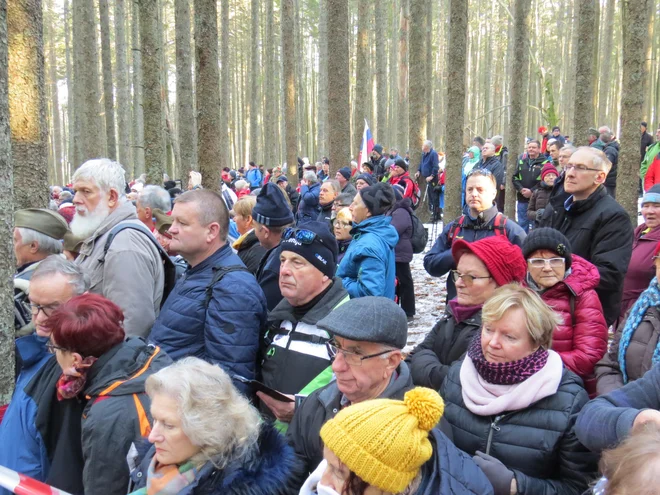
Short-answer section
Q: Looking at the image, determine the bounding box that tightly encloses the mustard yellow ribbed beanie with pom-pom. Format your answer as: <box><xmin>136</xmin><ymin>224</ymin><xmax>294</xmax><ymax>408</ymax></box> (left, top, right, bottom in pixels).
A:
<box><xmin>321</xmin><ymin>387</ymin><xmax>445</xmax><ymax>493</ymax></box>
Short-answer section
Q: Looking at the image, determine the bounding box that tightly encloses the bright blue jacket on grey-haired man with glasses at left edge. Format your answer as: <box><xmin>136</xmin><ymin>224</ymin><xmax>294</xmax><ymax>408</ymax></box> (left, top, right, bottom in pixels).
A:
<box><xmin>0</xmin><ymin>334</ymin><xmax>54</xmax><ymax>495</ymax></box>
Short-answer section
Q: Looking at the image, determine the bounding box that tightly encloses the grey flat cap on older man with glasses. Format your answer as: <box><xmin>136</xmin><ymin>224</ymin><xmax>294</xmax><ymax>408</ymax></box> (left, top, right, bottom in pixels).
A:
<box><xmin>316</xmin><ymin>296</ymin><xmax>408</xmax><ymax>349</ymax></box>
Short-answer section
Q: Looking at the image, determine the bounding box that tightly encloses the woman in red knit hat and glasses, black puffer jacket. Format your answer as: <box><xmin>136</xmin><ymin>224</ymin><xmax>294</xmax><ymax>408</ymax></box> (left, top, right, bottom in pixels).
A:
<box><xmin>407</xmin><ymin>236</ymin><xmax>527</xmax><ymax>390</ymax></box>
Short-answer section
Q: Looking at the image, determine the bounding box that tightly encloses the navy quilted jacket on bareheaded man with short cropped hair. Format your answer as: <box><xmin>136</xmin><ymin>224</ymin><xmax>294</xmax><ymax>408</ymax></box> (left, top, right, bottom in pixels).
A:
<box><xmin>149</xmin><ymin>244</ymin><xmax>267</xmax><ymax>392</ymax></box>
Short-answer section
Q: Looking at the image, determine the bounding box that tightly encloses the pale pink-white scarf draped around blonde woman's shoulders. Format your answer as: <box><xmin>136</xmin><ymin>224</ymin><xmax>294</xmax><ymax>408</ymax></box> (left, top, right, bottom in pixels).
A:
<box><xmin>460</xmin><ymin>350</ymin><xmax>564</xmax><ymax>416</ymax></box>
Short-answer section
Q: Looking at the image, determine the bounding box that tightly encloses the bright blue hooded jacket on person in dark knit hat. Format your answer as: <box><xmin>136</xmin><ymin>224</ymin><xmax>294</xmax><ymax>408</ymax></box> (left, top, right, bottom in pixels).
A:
<box><xmin>337</xmin><ymin>215</ymin><xmax>399</xmax><ymax>299</ymax></box>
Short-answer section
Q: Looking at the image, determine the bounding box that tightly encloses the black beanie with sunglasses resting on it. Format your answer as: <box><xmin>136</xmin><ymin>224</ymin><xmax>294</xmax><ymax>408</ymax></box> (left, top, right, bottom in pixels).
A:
<box><xmin>280</xmin><ymin>221</ymin><xmax>338</xmax><ymax>278</ymax></box>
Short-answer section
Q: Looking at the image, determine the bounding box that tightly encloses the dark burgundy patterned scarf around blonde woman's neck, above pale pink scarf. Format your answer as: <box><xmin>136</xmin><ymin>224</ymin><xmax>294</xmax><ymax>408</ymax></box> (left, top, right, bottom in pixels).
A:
<box><xmin>468</xmin><ymin>332</ymin><xmax>548</xmax><ymax>385</ymax></box>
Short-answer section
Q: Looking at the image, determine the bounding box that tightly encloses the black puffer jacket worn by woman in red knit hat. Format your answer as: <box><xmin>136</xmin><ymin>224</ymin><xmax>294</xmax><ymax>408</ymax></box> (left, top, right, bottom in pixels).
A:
<box><xmin>406</xmin><ymin>306</ymin><xmax>481</xmax><ymax>390</ymax></box>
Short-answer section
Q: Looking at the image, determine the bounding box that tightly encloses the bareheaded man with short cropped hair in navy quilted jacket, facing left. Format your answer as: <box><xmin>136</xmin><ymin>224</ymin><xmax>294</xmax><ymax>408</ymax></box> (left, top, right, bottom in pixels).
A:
<box><xmin>150</xmin><ymin>190</ymin><xmax>268</xmax><ymax>391</ymax></box>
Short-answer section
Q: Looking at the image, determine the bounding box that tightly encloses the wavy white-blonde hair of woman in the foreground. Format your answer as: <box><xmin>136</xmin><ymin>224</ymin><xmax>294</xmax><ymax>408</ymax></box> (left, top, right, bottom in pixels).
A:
<box><xmin>145</xmin><ymin>357</ymin><xmax>262</xmax><ymax>468</ymax></box>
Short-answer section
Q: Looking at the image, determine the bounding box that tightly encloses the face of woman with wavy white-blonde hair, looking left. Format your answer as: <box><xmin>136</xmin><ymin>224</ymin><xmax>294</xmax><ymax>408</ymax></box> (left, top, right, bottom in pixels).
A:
<box><xmin>149</xmin><ymin>394</ymin><xmax>202</xmax><ymax>465</ymax></box>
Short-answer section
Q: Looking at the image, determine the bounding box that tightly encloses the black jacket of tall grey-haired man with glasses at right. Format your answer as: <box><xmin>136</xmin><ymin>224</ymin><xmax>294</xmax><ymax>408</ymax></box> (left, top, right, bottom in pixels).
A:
<box><xmin>540</xmin><ymin>186</ymin><xmax>633</xmax><ymax>325</ymax></box>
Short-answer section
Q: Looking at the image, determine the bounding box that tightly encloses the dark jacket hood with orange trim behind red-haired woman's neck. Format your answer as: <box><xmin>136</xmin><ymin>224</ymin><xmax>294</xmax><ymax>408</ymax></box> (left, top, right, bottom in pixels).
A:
<box><xmin>85</xmin><ymin>337</ymin><xmax>172</xmax><ymax>397</ymax></box>
